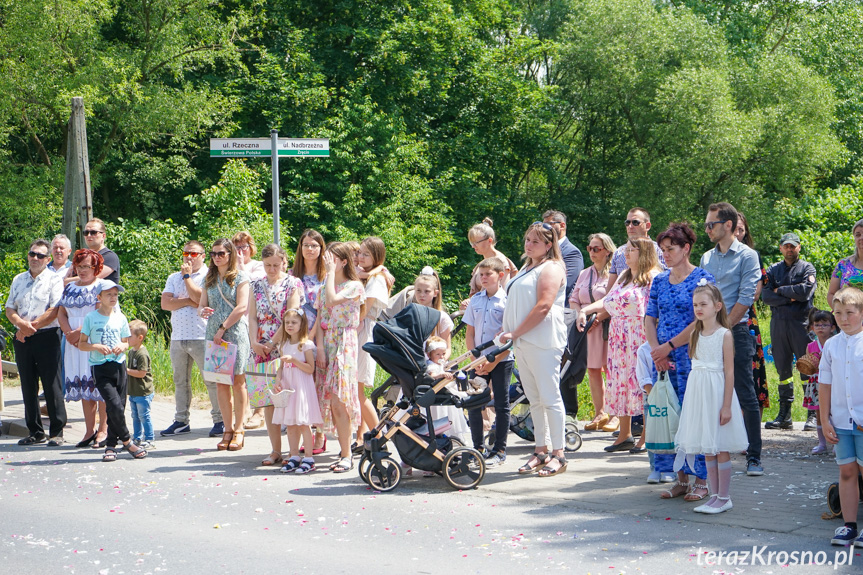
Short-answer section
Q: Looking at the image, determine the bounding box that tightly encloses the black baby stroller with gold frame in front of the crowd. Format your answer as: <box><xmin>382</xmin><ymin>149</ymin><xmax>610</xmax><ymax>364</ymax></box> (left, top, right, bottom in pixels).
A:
<box><xmin>359</xmin><ymin>304</ymin><xmax>512</xmax><ymax>491</ymax></box>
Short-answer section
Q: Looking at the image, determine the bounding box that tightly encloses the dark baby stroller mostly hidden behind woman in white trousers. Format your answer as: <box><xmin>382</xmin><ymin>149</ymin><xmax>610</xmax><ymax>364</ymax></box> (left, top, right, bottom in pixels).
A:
<box><xmin>483</xmin><ymin>315</ymin><xmax>596</xmax><ymax>452</ymax></box>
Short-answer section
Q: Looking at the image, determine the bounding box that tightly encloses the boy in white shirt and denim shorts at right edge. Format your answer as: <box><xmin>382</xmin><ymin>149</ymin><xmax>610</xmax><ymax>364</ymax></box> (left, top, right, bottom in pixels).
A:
<box><xmin>818</xmin><ymin>287</ymin><xmax>863</xmax><ymax>547</ymax></box>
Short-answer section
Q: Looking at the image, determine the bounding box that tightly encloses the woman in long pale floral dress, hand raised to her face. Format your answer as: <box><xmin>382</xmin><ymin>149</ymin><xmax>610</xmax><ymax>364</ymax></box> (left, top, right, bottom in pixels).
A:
<box><xmin>315</xmin><ymin>242</ymin><xmax>366</xmax><ymax>473</ymax></box>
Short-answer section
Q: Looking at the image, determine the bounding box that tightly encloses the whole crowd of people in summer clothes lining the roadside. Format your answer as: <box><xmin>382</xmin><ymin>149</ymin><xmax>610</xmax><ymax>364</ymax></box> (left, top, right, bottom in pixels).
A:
<box><xmin>6</xmin><ymin>207</ymin><xmax>863</xmax><ymax>546</ymax></box>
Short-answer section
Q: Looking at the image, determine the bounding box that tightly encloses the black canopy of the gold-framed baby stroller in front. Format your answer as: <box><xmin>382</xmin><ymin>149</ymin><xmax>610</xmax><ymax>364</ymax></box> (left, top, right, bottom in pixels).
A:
<box><xmin>363</xmin><ymin>303</ymin><xmax>441</xmax><ymax>376</ymax></box>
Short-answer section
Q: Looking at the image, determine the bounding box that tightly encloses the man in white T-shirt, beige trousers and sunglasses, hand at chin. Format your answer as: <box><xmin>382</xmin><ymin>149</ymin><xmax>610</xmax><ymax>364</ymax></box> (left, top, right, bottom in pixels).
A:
<box><xmin>159</xmin><ymin>240</ymin><xmax>225</xmax><ymax>437</ymax></box>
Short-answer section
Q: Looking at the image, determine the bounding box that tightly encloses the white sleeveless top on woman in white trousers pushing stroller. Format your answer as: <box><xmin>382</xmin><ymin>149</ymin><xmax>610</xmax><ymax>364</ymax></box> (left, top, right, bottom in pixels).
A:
<box><xmin>503</xmin><ymin>261</ymin><xmax>566</xmax><ymax>349</ymax></box>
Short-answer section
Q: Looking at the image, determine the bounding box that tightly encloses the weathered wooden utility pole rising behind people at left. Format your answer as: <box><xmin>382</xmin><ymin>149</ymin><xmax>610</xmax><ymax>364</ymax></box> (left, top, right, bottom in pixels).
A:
<box><xmin>62</xmin><ymin>97</ymin><xmax>93</xmax><ymax>252</ymax></box>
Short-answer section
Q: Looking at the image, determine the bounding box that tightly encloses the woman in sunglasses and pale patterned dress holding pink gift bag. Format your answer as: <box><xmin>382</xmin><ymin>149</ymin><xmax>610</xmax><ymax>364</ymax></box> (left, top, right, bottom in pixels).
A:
<box><xmin>198</xmin><ymin>238</ymin><xmax>251</xmax><ymax>451</ymax></box>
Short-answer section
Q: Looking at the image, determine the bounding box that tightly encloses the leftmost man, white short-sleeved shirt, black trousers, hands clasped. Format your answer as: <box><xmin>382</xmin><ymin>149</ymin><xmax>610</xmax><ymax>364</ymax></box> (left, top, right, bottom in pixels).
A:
<box><xmin>6</xmin><ymin>240</ymin><xmax>66</xmax><ymax>447</ymax></box>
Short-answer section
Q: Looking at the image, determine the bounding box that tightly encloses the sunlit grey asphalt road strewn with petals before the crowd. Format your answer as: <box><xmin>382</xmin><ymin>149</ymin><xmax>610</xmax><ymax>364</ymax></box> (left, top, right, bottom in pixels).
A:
<box><xmin>0</xmin><ymin>434</ymin><xmax>863</xmax><ymax>575</ymax></box>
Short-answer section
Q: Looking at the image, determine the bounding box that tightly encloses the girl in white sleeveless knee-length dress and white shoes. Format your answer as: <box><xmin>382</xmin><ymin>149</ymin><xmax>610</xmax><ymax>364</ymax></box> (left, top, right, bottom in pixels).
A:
<box><xmin>674</xmin><ymin>279</ymin><xmax>749</xmax><ymax>514</ymax></box>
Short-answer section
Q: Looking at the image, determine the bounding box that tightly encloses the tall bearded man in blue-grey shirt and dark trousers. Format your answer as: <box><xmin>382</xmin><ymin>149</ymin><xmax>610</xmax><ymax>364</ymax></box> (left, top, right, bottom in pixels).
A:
<box><xmin>700</xmin><ymin>202</ymin><xmax>764</xmax><ymax>475</ymax></box>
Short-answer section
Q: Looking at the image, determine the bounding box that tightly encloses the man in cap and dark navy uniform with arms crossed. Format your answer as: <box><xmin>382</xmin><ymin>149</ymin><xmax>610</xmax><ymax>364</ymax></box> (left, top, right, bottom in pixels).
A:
<box><xmin>761</xmin><ymin>233</ymin><xmax>816</xmax><ymax>431</ymax></box>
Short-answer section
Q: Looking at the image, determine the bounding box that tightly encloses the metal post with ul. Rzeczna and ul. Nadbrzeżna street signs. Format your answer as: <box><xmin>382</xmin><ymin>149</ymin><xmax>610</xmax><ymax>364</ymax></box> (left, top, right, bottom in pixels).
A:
<box><xmin>210</xmin><ymin>137</ymin><xmax>330</xmax><ymax>244</ymax></box>
